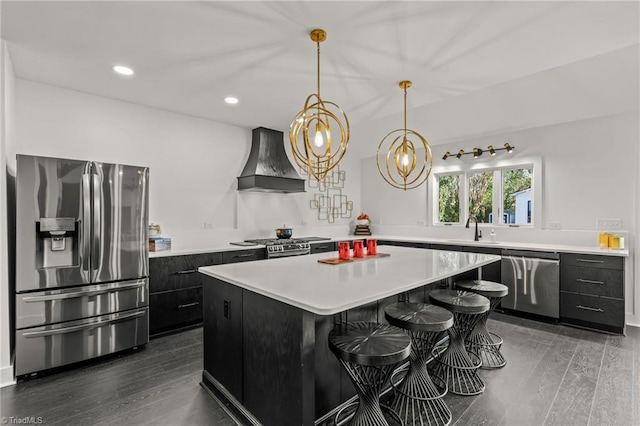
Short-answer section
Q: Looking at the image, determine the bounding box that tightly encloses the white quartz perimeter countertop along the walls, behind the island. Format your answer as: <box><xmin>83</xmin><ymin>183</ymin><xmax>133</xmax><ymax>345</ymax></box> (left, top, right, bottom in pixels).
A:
<box><xmin>149</xmin><ymin>235</ymin><xmax>629</xmax><ymax>258</ymax></box>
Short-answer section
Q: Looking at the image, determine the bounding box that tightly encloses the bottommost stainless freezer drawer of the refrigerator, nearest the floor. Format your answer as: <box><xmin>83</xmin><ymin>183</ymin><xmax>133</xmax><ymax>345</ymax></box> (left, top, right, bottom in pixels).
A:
<box><xmin>15</xmin><ymin>308</ymin><xmax>149</xmax><ymax>376</ymax></box>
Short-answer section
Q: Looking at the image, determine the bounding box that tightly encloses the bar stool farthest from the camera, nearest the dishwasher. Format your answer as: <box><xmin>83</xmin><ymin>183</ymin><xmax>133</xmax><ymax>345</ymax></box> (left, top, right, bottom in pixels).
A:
<box><xmin>455</xmin><ymin>280</ymin><xmax>509</xmax><ymax>369</ymax></box>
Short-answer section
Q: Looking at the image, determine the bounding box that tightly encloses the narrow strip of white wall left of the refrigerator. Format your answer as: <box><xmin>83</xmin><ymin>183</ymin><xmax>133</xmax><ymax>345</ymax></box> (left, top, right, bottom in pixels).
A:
<box><xmin>0</xmin><ymin>40</ymin><xmax>15</xmax><ymax>387</ymax></box>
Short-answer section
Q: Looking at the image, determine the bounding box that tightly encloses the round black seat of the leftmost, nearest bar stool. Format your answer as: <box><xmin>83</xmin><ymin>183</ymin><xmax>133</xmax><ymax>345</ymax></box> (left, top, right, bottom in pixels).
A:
<box><xmin>329</xmin><ymin>322</ymin><xmax>411</xmax><ymax>366</ymax></box>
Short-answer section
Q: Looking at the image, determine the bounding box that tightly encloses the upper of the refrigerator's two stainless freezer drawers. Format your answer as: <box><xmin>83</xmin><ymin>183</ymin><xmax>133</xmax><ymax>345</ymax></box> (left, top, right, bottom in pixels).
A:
<box><xmin>16</xmin><ymin>278</ymin><xmax>149</xmax><ymax>329</ymax></box>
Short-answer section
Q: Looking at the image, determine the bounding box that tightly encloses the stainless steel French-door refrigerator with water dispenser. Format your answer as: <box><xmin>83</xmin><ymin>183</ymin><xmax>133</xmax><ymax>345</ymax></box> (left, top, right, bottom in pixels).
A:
<box><xmin>15</xmin><ymin>155</ymin><xmax>149</xmax><ymax>376</ymax></box>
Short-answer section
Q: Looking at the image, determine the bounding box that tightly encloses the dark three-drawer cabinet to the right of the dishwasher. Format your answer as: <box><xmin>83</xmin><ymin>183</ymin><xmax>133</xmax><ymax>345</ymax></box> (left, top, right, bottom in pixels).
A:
<box><xmin>560</xmin><ymin>253</ymin><xmax>624</xmax><ymax>333</ymax></box>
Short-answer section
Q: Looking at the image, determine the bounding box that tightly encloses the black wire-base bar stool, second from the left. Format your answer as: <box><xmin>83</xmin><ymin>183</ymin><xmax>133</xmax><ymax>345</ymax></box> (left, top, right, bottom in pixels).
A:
<box><xmin>384</xmin><ymin>302</ymin><xmax>453</xmax><ymax>426</ymax></box>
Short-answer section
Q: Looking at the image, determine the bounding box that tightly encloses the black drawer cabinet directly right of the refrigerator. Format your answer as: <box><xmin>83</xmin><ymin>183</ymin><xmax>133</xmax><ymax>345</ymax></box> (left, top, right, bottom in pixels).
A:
<box><xmin>149</xmin><ymin>253</ymin><xmax>222</xmax><ymax>335</ymax></box>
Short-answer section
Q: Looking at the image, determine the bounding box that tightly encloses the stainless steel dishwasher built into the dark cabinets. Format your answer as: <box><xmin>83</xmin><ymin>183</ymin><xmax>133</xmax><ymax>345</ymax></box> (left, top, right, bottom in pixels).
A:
<box><xmin>501</xmin><ymin>250</ymin><xmax>560</xmax><ymax>318</ymax></box>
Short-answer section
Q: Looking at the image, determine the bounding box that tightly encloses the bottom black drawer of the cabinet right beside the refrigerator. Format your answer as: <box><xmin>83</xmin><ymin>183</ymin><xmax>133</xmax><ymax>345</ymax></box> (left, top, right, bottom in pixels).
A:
<box><xmin>149</xmin><ymin>287</ymin><xmax>202</xmax><ymax>334</ymax></box>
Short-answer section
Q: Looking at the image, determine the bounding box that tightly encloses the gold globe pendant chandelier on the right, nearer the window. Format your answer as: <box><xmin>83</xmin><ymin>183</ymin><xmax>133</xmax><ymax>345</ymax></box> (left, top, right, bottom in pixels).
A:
<box><xmin>376</xmin><ymin>80</ymin><xmax>433</xmax><ymax>191</ymax></box>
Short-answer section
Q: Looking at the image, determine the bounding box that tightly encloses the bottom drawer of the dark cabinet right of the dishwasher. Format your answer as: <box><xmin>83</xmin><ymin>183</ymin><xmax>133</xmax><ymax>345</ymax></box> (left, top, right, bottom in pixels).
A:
<box><xmin>560</xmin><ymin>292</ymin><xmax>624</xmax><ymax>328</ymax></box>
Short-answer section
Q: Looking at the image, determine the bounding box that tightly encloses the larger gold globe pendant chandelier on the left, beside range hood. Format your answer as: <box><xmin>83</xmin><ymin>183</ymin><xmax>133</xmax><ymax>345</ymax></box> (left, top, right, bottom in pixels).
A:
<box><xmin>289</xmin><ymin>29</ymin><xmax>350</xmax><ymax>181</ymax></box>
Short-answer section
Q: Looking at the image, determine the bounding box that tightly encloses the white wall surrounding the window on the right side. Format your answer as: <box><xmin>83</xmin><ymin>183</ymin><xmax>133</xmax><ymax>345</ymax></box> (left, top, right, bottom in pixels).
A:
<box><xmin>354</xmin><ymin>45</ymin><xmax>640</xmax><ymax>325</ymax></box>
